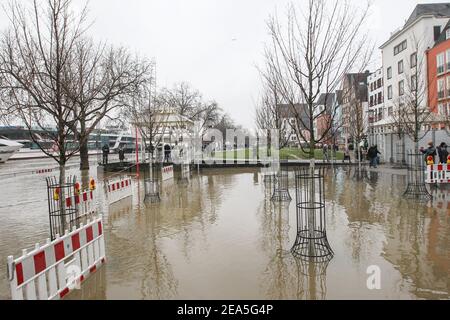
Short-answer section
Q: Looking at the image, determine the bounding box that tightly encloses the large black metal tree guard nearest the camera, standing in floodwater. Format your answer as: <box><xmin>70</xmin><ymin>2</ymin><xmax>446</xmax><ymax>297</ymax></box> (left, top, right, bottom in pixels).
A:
<box><xmin>291</xmin><ymin>166</ymin><xmax>334</xmax><ymax>262</ymax></box>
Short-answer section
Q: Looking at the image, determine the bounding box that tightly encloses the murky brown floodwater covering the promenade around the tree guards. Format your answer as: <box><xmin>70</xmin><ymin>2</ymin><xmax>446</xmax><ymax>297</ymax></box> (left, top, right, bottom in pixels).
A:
<box><xmin>0</xmin><ymin>162</ymin><xmax>450</xmax><ymax>299</ymax></box>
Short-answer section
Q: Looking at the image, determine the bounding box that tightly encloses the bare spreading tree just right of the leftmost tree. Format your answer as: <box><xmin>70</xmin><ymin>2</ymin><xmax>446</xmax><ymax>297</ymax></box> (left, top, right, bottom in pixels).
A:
<box><xmin>67</xmin><ymin>38</ymin><xmax>150</xmax><ymax>170</ymax></box>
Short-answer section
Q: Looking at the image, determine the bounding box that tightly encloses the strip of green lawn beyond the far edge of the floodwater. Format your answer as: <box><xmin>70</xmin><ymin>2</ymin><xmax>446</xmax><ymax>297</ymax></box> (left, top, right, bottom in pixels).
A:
<box><xmin>208</xmin><ymin>148</ymin><xmax>344</xmax><ymax>161</ymax></box>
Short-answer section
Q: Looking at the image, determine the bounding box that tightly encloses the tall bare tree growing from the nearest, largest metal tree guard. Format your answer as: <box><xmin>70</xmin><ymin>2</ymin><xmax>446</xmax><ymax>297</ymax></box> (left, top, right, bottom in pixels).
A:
<box><xmin>265</xmin><ymin>0</ymin><xmax>373</xmax><ymax>158</ymax></box>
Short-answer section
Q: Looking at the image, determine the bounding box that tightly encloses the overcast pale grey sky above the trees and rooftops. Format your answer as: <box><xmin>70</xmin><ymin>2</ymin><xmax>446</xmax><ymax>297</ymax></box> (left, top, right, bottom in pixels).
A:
<box><xmin>0</xmin><ymin>0</ymin><xmax>448</xmax><ymax>127</ymax></box>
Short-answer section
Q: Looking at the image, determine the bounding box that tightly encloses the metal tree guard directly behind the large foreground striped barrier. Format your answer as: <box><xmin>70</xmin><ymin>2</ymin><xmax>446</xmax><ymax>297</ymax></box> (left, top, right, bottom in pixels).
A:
<box><xmin>46</xmin><ymin>176</ymin><xmax>80</xmax><ymax>241</ymax></box>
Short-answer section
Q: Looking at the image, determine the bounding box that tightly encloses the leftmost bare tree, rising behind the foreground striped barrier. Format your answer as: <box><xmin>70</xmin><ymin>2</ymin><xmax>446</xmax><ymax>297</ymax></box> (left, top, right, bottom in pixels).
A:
<box><xmin>0</xmin><ymin>0</ymin><xmax>86</xmax><ymax>184</ymax></box>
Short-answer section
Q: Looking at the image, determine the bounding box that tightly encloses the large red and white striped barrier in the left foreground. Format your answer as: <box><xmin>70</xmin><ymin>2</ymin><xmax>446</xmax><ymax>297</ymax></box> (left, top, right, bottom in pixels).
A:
<box><xmin>8</xmin><ymin>217</ymin><xmax>106</xmax><ymax>300</ymax></box>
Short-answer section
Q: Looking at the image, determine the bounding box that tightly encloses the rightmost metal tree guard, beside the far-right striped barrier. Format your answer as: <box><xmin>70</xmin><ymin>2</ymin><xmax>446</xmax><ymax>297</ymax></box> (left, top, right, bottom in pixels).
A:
<box><xmin>403</xmin><ymin>151</ymin><xmax>433</xmax><ymax>201</ymax></box>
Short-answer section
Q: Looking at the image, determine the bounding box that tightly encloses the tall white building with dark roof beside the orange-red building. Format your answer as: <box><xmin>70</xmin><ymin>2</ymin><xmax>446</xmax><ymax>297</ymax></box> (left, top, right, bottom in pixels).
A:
<box><xmin>369</xmin><ymin>3</ymin><xmax>450</xmax><ymax>162</ymax></box>
